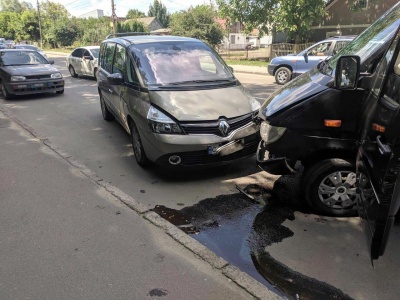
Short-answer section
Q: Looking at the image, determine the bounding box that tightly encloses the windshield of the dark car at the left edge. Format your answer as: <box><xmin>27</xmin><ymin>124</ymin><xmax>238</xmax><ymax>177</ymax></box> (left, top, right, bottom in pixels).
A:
<box><xmin>0</xmin><ymin>51</ymin><xmax>49</xmax><ymax>66</ymax></box>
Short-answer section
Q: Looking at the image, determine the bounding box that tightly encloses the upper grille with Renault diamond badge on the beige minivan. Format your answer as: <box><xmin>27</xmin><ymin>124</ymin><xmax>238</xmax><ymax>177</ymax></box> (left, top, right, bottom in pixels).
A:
<box><xmin>179</xmin><ymin>113</ymin><xmax>253</xmax><ymax>136</ymax></box>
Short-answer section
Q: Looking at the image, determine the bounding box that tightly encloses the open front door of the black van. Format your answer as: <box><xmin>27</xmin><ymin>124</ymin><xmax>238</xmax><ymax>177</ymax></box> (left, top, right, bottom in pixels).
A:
<box><xmin>357</xmin><ymin>26</ymin><xmax>400</xmax><ymax>259</ymax></box>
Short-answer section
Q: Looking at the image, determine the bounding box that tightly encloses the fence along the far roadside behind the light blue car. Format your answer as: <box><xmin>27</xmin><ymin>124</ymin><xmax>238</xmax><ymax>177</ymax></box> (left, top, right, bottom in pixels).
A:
<box><xmin>217</xmin><ymin>43</ymin><xmax>314</xmax><ymax>61</ymax></box>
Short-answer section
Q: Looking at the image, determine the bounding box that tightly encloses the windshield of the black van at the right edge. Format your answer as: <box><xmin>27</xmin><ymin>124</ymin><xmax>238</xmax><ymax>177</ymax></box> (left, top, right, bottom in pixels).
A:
<box><xmin>329</xmin><ymin>3</ymin><xmax>400</xmax><ymax>72</ymax></box>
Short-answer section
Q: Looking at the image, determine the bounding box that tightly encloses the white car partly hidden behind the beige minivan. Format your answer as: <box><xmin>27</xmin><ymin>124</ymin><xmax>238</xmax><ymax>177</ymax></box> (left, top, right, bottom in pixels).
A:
<box><xmin>66</xmin><ymin>46</ymin><xmax>100</xmax><ymax>78</ymax></box>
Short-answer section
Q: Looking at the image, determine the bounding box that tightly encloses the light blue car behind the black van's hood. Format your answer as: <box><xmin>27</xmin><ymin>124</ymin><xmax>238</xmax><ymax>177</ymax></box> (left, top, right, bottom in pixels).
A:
<box><xmin>268</xmin><ymin>36</ymin><xmax>354</xmax><ymax>84</ymax></box>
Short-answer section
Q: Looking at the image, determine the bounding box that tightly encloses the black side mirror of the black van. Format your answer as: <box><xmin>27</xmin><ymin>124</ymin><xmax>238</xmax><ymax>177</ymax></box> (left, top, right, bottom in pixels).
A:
<box><xmin>335</xmin><ymin>55</ymin><xmax>360</xmax><ymax>90</ymax></box>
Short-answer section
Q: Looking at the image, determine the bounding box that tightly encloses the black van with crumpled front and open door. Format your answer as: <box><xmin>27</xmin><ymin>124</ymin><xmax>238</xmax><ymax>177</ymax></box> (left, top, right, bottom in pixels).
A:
<box><xmin>256</xmin><ymin>2</ymin><xmax>400</xmax><ymax>259</ymax></box>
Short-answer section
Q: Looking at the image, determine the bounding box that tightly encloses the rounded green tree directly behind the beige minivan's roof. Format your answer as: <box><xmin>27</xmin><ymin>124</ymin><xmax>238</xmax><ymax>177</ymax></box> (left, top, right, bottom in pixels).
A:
<box><xmin>170</xmin><ymin>5</ymin><xmax>224</xmax><ymax>47</ymax></box>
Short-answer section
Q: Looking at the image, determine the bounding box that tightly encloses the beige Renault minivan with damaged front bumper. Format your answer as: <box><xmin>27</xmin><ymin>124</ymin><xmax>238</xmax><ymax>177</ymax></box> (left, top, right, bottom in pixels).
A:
<box><xmin>98</xmin><ymin>35</ymin><xmax>260</xmax><ymax>167</ymax></box>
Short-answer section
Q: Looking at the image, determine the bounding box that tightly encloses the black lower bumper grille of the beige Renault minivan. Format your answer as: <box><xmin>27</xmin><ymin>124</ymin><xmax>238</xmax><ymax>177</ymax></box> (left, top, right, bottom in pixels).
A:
<box><xmin>156</xmin><ymin>133</ymin><xmax>260</xmax><ymax>167</ymax></box>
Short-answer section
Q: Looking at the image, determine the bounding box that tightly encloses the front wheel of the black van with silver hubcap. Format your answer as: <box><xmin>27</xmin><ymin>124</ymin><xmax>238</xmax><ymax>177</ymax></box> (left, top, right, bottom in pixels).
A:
<box><xmin>303</xmin><ymin>158</ymin><xmax>357</xmax><ymax>217</ymax></box>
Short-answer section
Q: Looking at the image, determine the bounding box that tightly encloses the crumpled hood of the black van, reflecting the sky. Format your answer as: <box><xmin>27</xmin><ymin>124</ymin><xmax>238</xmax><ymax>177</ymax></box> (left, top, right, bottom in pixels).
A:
<box><xmin>259</xmin><ymin>68</ymin><xmax>333</xmax><ymax>119</ymax></box>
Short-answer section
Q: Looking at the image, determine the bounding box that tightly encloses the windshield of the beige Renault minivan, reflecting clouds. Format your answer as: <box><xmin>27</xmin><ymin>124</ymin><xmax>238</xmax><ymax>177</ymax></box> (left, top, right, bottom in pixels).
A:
<box><xmin>130</xmin><ymin>41</ymin><xmax>234</xmax><ymax>85</ymax></box>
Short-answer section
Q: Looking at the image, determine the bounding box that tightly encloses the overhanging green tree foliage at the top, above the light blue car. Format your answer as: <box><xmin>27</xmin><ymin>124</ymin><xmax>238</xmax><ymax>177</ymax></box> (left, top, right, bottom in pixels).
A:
<box><xmin>216</xmin><ymin>0</ymin><xmax>326</xmax><ymax>41</ymax></box>
